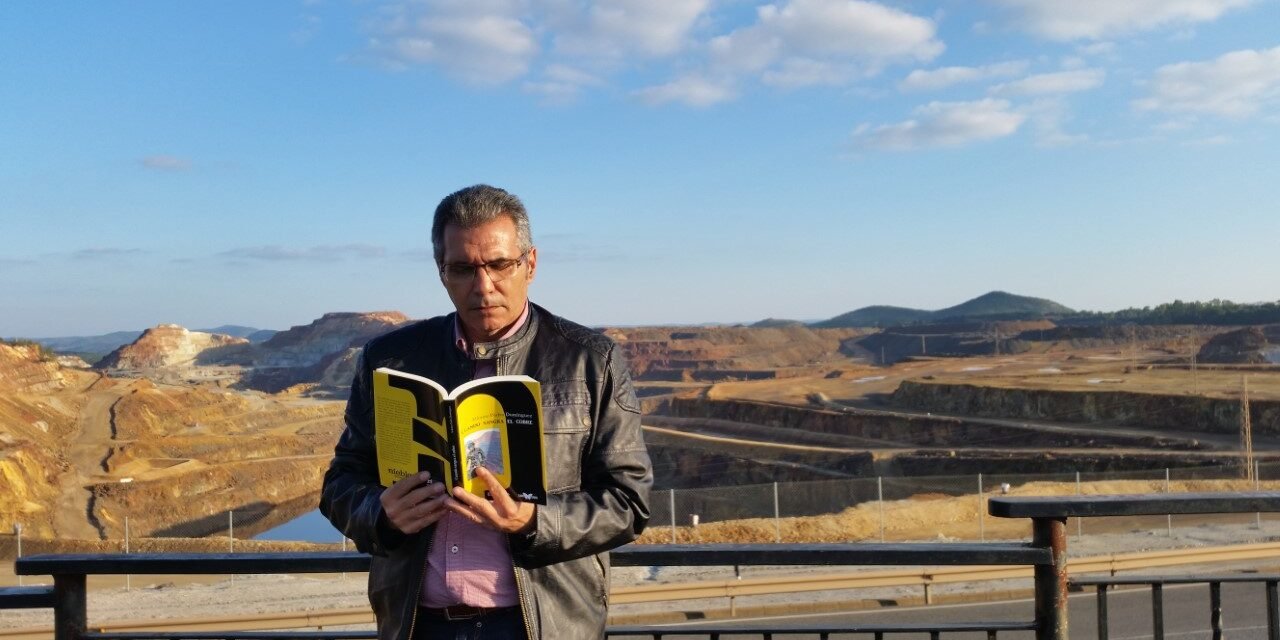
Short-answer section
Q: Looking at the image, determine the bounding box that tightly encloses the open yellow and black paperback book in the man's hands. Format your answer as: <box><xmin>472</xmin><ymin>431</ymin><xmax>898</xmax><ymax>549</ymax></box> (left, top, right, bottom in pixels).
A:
<box><xmin>374</xmin><ymin>367</ymin><xmax>547</xmax><ymax>504</ymax></box>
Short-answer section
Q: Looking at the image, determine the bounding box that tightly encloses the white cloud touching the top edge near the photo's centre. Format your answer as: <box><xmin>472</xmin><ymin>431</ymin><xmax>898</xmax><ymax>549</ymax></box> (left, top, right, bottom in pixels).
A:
<box><xmin>554</xmin><ymin>0</ymin><xmax>710</xmax><ymax>56</ymax></box>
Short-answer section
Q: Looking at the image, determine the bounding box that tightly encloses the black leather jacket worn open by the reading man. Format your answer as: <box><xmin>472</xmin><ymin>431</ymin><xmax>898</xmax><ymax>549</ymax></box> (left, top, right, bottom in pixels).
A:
<box><xmin>320</xmin><ymin>305</ymin><xmax>653</xmax><ymax>640</ymax></box>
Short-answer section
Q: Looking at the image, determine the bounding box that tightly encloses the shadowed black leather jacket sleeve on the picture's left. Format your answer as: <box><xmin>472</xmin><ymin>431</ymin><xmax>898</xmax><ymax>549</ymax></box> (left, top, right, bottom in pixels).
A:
<box><xmin>320</xmin><ymin>347</ymin><xmax>404</xmax><ymax>556</ymax></box>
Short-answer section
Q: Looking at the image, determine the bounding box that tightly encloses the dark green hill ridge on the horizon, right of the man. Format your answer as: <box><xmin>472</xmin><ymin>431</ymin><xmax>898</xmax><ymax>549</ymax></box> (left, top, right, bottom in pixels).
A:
<box><xmin>810</xmin><ymin>291</ymin><xmax>1075</xmax><ymax>328</ymax></box>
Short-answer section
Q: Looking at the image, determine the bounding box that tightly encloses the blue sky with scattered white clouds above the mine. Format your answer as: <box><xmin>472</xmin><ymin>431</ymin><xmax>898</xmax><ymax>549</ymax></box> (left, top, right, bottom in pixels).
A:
<box><xmin>0</xmin><ymin>0</ymin><xmax>1280</xmax><ymax>337</ymax></box>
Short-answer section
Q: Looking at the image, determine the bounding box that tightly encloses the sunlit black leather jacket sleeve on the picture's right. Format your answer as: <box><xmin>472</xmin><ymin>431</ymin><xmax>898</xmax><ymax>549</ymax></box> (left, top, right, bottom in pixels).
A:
<box><xmin>512</xmin><ymin>346</ymin><xmax>653</xmax><ymax>566</ymax></box>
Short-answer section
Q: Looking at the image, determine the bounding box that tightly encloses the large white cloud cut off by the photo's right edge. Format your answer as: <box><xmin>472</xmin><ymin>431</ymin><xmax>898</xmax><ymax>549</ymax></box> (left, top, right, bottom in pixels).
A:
<box><xmin>1134</xmin><ymin>47</ymin><xmax>1280</xmax><ymax>118</ymax></box>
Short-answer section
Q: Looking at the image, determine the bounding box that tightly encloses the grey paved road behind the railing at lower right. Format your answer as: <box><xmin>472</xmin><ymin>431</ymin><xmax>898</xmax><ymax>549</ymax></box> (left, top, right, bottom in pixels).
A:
<box><xmin>614</xmin><ymin>584</ymin><xmax>1267</xmax><ymax>640</ymax></box>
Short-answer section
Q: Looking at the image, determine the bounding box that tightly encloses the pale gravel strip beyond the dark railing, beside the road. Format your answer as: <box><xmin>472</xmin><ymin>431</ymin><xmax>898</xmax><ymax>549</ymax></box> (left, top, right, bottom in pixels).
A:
<box><xmin>0</xmin><ymin>522</ymin><xmax>1280</xmax><ymax>628</ymax></box>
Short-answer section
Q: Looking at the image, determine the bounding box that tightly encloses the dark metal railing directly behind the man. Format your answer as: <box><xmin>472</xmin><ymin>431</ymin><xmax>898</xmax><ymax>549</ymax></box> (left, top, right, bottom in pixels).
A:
<box><xmin>0</xmin><ymin>492</ymin><xmax>1280</xmax><ymax>640</ymax></box>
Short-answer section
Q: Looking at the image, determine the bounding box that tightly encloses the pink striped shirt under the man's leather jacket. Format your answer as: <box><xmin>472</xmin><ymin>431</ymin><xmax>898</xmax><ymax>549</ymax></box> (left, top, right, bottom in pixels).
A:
<box><xmin>421</xmin><ymin>301</ymin><xmax>529</xmax><ymax>608</ymax></box>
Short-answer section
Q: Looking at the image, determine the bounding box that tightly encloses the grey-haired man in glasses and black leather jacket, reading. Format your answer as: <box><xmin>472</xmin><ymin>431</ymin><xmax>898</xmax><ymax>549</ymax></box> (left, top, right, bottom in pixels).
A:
<box><xmin>320</xmin><ymin>184</ymin><xmax>653</xmax><ymax>640</ymax></box>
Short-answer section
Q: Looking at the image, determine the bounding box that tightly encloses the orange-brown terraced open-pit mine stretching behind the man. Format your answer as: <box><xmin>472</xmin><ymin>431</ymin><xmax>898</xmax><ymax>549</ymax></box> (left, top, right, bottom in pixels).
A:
<box><xmin>0</xmin><ymin>322</ymin><xmax>1280</xmax><ymax>554</ymax></box>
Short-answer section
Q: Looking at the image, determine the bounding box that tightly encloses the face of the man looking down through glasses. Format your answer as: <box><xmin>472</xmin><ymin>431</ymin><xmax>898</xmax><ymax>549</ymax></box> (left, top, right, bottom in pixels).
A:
<box><xmin>442</xmin><ymin>216</ymin><xmax>538</xmax><ymax>342</ymax></box>
